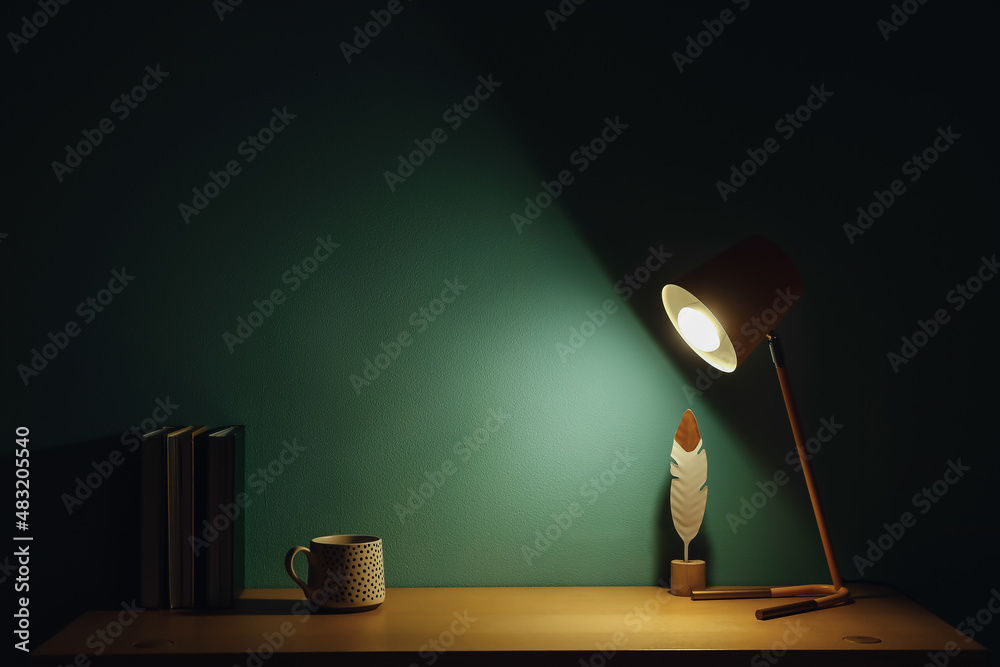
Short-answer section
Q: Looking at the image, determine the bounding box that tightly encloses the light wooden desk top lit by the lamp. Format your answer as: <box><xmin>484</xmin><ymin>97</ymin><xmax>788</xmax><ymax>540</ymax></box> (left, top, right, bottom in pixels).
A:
<box><xmin>32</xmin><ymin>585</ymin><xmax>987</xmax><ymax>667</ymax></box>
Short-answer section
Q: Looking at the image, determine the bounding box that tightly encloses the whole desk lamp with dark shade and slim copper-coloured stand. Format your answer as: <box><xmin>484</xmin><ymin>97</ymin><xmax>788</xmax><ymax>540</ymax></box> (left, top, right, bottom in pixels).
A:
<box><xmin>663</xmin><ymin>236</ymin><xmax>851</xmax><ymax>620</ymax></box>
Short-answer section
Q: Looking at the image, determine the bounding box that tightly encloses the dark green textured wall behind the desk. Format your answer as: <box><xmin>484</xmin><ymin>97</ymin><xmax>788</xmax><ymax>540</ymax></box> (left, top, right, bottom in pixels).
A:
<box><xmin>0</xmin><ymin>2</ymin><xmax>1000</xmax><ymax>656</ymax></box>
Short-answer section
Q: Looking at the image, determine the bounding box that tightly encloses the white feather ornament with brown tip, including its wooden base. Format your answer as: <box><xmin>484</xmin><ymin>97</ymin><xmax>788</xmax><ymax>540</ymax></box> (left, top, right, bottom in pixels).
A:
<box><xmin>670</xmin><ymin>410</ymin><xmax>708</xmax><ymax>597</ymax></box>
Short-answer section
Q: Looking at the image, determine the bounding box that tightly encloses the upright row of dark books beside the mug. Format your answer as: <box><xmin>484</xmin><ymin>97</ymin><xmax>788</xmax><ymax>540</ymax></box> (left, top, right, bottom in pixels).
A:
<box><xmin>139</xmin><ymin>426</ymin><xmax>246</xmax><ymax>609</ymax></box>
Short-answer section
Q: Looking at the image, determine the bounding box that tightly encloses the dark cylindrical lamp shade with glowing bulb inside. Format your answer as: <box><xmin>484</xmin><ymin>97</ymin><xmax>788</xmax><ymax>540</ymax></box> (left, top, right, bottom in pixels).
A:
<box><xmin>662</xmin><ymin>236</ymin><xmax>802</xmax><ymax>373</ymax></box>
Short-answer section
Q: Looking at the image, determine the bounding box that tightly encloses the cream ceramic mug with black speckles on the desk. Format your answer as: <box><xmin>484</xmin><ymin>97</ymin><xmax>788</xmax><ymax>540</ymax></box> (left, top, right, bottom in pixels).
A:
<box><xmin>285</xmin><ymin>535</ymin><xmax>385</xmax><ymax>611</ymax></box>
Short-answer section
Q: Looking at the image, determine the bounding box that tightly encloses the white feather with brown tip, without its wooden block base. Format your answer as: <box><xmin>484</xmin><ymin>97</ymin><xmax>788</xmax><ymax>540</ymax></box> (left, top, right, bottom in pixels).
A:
<box><xmin>670</xmin><ymin>410</ymin><xmax>708</xmax><ymax>560</ymax></box>
